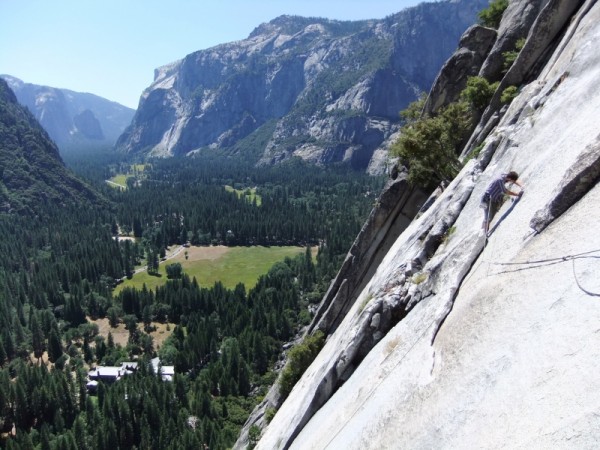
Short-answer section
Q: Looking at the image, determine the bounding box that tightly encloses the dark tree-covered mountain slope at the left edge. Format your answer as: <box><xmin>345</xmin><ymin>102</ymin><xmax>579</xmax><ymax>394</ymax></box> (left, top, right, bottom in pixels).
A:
<box><xmin>0</xmin><ymin>79</ymin><xmax>102</xmax><ymax>214</ymax></box>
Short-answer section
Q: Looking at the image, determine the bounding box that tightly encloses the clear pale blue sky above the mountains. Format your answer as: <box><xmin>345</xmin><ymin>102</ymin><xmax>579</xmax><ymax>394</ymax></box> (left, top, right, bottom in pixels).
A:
<box><xmin>0</xmin><ymin>0</ymin><xmax>421</xmax><ymax>108</ymax></box>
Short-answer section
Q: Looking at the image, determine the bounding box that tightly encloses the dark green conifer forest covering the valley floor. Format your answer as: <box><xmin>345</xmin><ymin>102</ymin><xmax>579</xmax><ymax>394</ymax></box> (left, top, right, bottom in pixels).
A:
<box><xmin>0</xmin><ymin>139</ymin><xmax>383</xmax><ymax>450</ymax></box>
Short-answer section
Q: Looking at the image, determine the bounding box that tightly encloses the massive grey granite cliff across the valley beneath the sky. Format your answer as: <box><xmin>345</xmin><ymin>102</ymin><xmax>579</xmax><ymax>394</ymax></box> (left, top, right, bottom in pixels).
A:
<box><xmin>117</xmin><ymin>0</ymin><xmax>487</xmax><ymax>172</ymax></box>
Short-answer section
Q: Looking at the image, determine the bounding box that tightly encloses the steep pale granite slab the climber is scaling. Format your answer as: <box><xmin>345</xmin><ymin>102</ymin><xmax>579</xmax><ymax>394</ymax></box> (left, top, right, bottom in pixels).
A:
<box><xmin>247</xmin><ymin>0</ymin><xmax>600</xmax><ymax>449</ymax></box>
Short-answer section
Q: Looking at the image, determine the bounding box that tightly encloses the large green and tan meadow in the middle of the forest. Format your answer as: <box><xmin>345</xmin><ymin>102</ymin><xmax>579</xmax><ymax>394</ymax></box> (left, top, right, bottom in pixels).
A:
<box><xmin>114</xmin><ymin>246</ymin><xmax>305</xmax><ymax>294</ymax></box>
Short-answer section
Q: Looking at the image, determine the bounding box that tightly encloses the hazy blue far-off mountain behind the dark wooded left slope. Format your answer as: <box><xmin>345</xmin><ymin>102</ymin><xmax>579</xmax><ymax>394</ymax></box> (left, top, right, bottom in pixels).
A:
<box><xmin>0</xmin><ymin>75</ymin><xmax>135</xmax><ymax>148</ymax></box>
